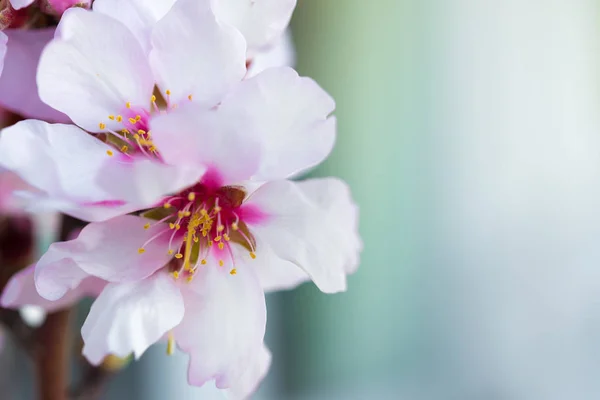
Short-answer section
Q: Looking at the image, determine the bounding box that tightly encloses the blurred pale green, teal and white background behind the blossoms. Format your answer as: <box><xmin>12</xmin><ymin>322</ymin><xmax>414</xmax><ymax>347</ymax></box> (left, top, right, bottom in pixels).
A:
<box><xmin>8</xmin><ymin>0</ymin><xmax>600</xmax><ymax>400</ymax></box>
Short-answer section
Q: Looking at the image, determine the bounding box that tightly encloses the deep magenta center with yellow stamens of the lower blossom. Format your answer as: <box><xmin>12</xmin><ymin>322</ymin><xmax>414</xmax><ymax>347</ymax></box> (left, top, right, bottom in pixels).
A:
<box><xmin>138</xmin><ymin>171</ymin><xmax>264</xmax><ymax>281</ymax></box>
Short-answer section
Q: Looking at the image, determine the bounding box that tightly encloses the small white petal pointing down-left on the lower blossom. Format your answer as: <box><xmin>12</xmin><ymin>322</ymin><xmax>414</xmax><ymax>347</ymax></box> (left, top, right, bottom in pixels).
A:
<box><xmin>81</xmin><ymin>273</ymin><xmax>184</xmax><ymax>365</ymax></box>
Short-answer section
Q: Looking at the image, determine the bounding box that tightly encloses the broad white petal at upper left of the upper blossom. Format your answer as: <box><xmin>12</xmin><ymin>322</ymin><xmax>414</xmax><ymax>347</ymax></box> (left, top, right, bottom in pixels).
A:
<box><xmin>37</xmin><ymin>8</ymin><xmax>154</xmax><ymax>132</ymax></box>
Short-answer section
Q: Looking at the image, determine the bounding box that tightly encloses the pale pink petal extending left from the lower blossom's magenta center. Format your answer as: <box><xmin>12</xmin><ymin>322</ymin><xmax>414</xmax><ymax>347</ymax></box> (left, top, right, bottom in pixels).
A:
<box><xmin>35</xmin><ymin>215</ymin><xmax>182</xmax><ymax>300</ymax></box>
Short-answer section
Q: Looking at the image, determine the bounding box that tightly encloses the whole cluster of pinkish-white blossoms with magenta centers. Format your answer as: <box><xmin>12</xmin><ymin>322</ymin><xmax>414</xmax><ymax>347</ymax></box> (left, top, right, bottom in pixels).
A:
<box><xmin>0</xmin><ymin>0</ymin><xmax>362</xmax><ymax>398</ymax></box>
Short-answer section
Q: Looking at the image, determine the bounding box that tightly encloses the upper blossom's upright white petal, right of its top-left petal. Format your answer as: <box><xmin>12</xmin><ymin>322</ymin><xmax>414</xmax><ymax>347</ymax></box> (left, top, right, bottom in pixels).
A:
<box><xmin>150</xmin><ymin>0</ymin><xmax>246</xmax><ymax>107</ymax></box>
